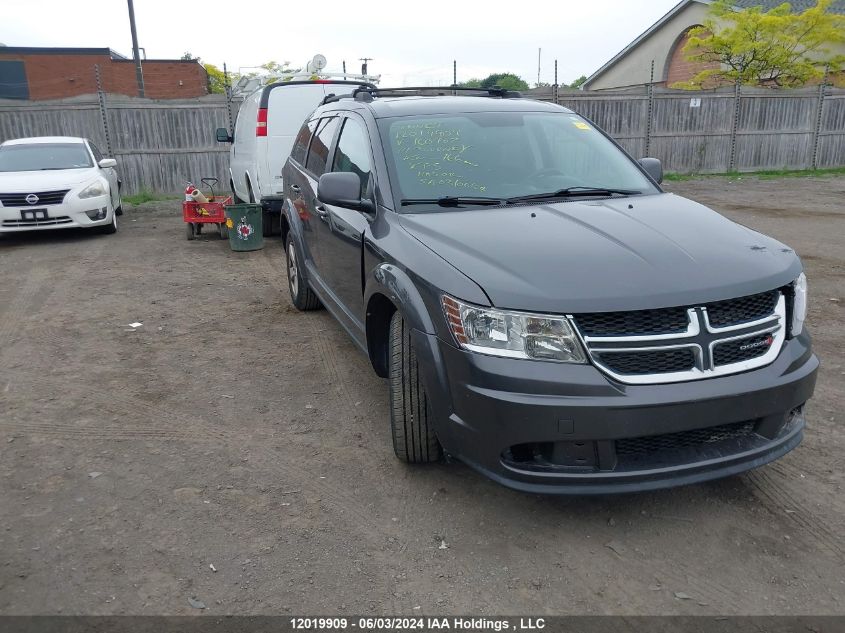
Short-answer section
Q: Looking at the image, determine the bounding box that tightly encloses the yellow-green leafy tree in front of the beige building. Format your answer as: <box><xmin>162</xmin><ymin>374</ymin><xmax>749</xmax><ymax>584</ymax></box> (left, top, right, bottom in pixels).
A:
<box><xmin>673</xmin><ymin>0</ymin><xmax>845</xmax><ymax>90</ymax></box>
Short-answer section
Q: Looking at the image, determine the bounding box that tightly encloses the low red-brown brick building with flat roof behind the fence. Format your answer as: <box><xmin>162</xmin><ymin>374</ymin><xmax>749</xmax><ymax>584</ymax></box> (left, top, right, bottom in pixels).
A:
<box><xmin>0</xmin><ymin>46</ymin><xmax>208</xmax><ymax>101</ymax></box>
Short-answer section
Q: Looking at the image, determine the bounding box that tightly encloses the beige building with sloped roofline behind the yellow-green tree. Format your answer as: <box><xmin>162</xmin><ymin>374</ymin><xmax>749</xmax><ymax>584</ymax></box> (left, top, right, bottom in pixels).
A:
<box><xmin>583</xmin><ymin>0</ymin><xmax>845</xmax><ymax>90</ymax></box>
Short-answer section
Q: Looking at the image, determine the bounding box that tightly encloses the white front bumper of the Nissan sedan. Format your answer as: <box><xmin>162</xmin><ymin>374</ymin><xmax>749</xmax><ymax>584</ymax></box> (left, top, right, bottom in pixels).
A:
<box><xmin>0</xmin><ymin>193</ymin><xmax>114</xmax><ymax>233</ymax></box>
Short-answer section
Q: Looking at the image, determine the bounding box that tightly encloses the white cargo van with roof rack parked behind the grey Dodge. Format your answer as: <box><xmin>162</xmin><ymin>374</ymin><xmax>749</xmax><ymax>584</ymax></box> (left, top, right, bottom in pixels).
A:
<box><xmin>217</xmin><ymin>75</ymin><xmax>377</xmax><ymax>235</ymax></box>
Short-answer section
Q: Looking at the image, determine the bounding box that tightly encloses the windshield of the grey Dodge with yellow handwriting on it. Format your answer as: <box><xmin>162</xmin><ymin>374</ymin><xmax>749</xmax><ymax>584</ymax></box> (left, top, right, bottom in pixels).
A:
<box><xmin>379</xmin><ymin>112</ymin><xmax>659</xmax><ymax>212</ymax></box>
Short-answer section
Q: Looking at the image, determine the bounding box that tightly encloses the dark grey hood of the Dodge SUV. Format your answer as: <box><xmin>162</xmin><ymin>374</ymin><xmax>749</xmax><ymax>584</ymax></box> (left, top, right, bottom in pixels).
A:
<box><xmin>400</xmin><ymin>193</ymin><xmax>801</xmax><ymax>313</ymax></box>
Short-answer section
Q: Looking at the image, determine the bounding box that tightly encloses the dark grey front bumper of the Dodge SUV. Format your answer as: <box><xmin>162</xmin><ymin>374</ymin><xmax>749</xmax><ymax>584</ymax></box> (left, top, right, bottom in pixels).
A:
<box><xmin>415</xmin><ymin>332</ymin><xmax>819</xmax><ymax>494</ymax></box>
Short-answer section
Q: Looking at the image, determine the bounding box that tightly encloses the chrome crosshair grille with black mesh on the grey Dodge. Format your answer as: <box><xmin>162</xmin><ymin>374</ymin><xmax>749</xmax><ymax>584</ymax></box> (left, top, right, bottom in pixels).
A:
<box><xmin>571</xmin><ymin>290</ymin><xmax>786</xmax><ymax>384</ymax></box>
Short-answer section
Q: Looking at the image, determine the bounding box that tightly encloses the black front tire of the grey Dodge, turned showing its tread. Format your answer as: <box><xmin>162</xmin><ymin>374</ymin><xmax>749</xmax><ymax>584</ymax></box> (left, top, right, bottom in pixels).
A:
<box><xmin>389</xmin><ymin>311</ymin><xmax>441</xmax><ymax>464</ymax></box>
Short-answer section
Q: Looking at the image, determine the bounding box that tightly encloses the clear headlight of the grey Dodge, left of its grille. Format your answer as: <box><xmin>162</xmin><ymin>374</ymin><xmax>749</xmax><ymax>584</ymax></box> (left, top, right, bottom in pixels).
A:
<box><xmin>443</xmin><ymin>295</ymin><xmax>587</xmax><ymax>363</ymax></box>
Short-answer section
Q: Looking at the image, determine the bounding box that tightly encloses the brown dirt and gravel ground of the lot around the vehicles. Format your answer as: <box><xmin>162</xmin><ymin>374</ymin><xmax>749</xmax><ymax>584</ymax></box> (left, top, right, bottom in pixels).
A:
<box><xmin>0</xmin><ymin>177</ymin><xmax>845</xmax><ymax>615</ymax></box>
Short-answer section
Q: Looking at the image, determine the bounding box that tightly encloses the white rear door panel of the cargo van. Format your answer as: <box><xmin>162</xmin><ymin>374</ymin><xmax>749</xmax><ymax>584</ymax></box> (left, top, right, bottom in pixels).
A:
<box><xmin>264</xmin><ymin>83</ymin><xmax>330</xmax><ymax>196</ymax></box>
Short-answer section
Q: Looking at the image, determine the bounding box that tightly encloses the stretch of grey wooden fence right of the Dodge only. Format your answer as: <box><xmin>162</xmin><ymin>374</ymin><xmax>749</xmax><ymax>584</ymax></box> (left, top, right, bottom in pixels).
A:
<box><xmin>532</xmin><ymin>86</ymin><xmax>845</xmax><ymax>174</ymax></box>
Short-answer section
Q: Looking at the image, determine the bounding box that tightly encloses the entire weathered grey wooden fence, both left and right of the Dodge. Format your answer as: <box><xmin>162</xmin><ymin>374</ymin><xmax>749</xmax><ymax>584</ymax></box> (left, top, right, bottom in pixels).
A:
<box><xmin>0</xmin><ymin>86</ymin><xmax>845</xmax><ymax>194</ymax></box>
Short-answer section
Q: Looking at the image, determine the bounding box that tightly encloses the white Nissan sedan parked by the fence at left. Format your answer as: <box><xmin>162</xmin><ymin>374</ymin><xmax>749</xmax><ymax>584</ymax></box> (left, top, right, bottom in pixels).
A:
<box><xmin>0</xmin><ymin>136</ymin><xmax>123</xmax><ymax>233</ymax></box>
